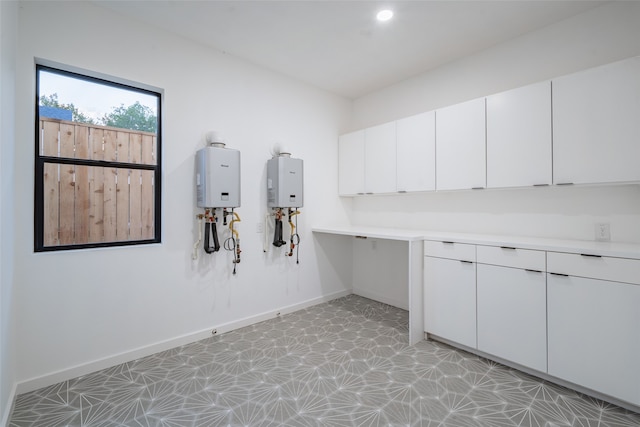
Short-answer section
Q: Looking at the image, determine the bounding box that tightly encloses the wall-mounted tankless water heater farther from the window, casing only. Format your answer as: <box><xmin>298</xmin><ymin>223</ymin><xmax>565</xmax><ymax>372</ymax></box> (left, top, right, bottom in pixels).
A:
<box><xmin>267</xmin><ymin>154</ymin><xmax>303</xmax><ymax>208</ymax></box>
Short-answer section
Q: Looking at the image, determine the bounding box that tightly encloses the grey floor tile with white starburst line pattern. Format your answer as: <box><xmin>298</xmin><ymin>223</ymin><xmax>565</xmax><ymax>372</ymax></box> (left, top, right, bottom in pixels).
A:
<box><xmin>9</xmin><ymin>295</ymin><xmax>640</xmax><ymax>427</ymax></box>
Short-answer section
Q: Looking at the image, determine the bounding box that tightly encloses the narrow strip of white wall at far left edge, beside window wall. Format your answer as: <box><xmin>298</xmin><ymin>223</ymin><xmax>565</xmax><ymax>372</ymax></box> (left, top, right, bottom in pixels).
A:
<box><xmin>0</xmin><ymin>1</ymin><xmax>18</xmax><ymax>425</ymax></box>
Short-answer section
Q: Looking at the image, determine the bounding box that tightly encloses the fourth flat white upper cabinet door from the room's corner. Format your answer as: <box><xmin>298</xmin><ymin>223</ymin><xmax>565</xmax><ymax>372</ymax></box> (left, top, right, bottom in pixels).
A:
<box><xmin>436</xmin><ymin>98</ymin><xmax>486</xmax><ymax>190</ymax></box>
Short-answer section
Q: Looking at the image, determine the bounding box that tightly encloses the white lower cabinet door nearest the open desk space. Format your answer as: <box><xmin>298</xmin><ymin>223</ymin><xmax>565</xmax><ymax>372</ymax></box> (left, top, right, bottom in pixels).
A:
<box><xmin>424</xmin><ymin>257</ymin><xmax>476</xmax><ymax>348</ymax></box>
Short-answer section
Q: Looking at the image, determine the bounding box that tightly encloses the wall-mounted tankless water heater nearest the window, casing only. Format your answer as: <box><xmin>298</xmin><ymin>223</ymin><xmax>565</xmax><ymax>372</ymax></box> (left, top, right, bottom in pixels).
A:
<box><xmin>196</xmin><ymin>144</ymin><xmax>240</xmax><ymax>208</ymax></box>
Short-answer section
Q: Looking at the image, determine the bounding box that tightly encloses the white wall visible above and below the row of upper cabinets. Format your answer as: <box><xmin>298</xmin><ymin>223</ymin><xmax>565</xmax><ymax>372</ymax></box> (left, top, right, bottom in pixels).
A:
<box><xmin>351</xmin><ymin>2</ymin><xmax>640</xmax><ymax>242</ymax></box>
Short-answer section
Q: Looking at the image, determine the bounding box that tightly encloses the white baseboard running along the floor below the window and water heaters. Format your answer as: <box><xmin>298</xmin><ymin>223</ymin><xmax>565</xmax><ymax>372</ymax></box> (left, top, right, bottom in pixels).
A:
<box><xmin>15</xmin><ymin>289</ymin><xmax>353</xmax><ymax>396</ymax></box>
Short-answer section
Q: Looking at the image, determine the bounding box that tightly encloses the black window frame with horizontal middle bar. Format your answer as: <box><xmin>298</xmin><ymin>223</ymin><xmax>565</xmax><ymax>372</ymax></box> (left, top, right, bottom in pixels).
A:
<box><xmin>34</xmin><ymin>62</ymin><xmax>163</xmax><ymax>252</ymax></box>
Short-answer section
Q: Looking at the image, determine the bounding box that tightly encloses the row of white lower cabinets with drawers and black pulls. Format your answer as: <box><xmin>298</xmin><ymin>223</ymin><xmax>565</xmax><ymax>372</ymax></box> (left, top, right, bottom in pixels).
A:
<box><xmin>424</xmin><ymin>240</ymin><xmax>640</xmax><ymax>407</ymax></box>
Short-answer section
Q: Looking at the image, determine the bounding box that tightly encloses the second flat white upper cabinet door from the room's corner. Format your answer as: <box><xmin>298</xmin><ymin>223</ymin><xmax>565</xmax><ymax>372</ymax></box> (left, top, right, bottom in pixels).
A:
<box><xmin>364</xmin><ymin>122</ymin><xmax>396</xmax><ymax>194</ymax></box>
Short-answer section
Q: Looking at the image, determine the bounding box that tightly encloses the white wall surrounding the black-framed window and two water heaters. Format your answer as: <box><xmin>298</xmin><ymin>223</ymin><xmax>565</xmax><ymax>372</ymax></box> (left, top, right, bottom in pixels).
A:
<box><xmin>14</xmin><ymin>2</ymin><xmax>351</xmax><ymax>391</ymax></box>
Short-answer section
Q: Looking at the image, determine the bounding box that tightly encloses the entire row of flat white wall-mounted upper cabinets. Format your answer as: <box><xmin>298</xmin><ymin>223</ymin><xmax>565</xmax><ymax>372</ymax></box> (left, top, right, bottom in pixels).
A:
<box><xmin>339</xmin><ymin>57</ymin><xmax>640</xmax><ymax>195</ymax></box>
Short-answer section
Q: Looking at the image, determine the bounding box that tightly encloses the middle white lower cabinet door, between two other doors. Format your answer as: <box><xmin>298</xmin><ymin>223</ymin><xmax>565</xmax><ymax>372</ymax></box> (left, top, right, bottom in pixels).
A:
<box><xmin>477</xmin><ymin>264</ymin><xmax>547</xmax><ymax>372</ymax></box>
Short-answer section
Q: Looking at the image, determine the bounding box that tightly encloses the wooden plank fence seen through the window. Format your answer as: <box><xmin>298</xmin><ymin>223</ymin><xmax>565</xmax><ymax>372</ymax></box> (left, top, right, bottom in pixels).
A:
<box><xmin>40</xmin><ymin>118</ymin><xmax>157</xmax><ymax>247</ymax></box>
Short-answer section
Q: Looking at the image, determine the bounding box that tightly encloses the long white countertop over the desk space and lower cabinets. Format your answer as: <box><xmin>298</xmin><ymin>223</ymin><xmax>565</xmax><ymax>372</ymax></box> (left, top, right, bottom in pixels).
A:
<box><xmin>312</xmin><ymin>225</ymin><xmax>640</xmax><ymax>259</ymax></box>
